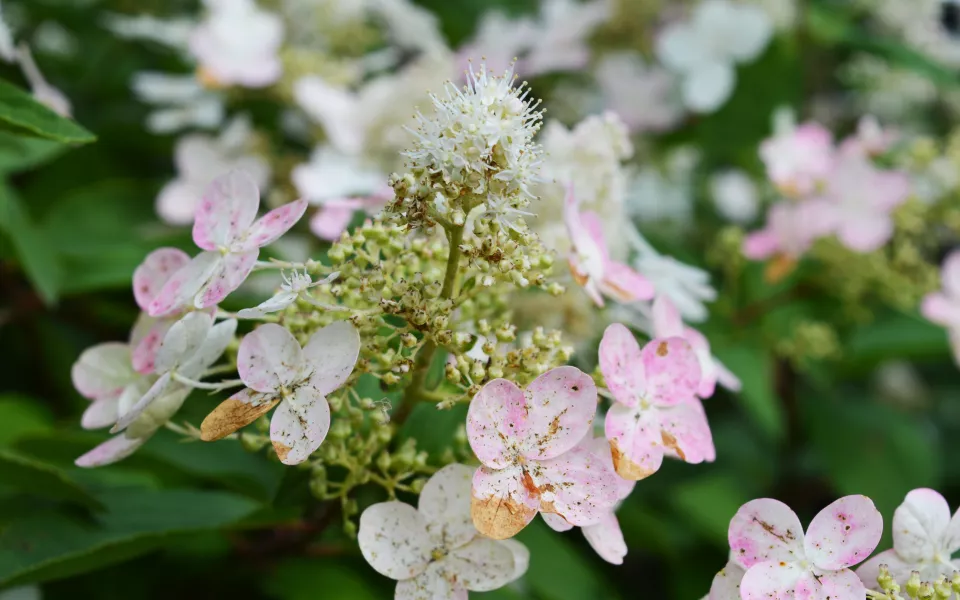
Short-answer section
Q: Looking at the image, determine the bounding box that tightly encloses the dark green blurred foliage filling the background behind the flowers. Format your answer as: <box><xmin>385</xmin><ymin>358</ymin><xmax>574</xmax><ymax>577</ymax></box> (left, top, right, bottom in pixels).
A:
<box><xmin>0</xmin><ymin>0</ymin><xmax>960</xmax><ymax>600</ymax></box>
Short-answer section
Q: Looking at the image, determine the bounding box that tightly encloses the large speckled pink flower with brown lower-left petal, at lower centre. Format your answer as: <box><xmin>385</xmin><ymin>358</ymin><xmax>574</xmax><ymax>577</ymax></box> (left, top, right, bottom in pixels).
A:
<box><xmin>467</xmin><ymin>367</ymin><xmax>617</xmax><ymax>539</ymax></box>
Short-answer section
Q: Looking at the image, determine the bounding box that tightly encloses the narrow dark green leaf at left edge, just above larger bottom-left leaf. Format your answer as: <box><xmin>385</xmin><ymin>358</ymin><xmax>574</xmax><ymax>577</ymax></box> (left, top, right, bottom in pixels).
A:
<box><xmin>0</xmin><ymin>449</ymin><xmax>102</xmax><ymax>508</ymax></box>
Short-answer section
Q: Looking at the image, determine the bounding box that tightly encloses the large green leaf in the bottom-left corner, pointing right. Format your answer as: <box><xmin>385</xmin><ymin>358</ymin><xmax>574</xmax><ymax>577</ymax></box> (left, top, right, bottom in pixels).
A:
<box><xmin>0</xmin><ymin>490</ymin><xmax>257</xmax><ymax>586</ymax></box>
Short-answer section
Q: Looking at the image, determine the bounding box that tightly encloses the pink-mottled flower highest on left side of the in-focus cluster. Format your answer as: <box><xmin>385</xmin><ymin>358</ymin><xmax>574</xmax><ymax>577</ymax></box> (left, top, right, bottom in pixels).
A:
<box><xmin>147</xmin><ymin>171</ymin><xmax>307</xmax><ymax>317</ymax></box>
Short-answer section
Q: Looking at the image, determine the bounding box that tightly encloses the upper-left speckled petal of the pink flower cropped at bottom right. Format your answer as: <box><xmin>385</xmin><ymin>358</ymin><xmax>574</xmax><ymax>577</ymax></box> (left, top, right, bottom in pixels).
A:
<box><xmin>728</xmin><ymin>498</ymin><xmax>804</xmax><ymax>569</ymax></box>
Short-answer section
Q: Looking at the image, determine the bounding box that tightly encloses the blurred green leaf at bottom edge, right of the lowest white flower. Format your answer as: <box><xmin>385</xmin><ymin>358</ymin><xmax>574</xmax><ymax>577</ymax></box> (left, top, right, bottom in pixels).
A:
<box><xmin>517</xmin><ymin>519</ymin><xmax>616</xmax><ymax>600</ymax></box>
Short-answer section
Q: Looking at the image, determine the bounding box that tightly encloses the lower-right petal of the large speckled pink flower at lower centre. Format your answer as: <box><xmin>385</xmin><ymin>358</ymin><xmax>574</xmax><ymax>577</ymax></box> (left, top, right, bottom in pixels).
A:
<box><xmin>531</xmin><ymin>446</ymin><xmax>619</xmax><ymax>526</ymax></box>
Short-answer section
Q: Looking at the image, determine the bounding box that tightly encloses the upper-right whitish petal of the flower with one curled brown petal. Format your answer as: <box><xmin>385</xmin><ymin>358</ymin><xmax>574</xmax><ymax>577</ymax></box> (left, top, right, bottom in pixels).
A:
<box><xmin>303</xmin><ymin>321</ymin><xmax>360</xmax><ymax>395</ymax></box>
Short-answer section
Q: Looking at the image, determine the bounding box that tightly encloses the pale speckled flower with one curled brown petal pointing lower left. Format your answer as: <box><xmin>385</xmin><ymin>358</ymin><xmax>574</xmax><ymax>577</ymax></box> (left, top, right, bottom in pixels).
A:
<box><xmin>200</xmin><ymin>321</ymin><xmax>360</xmax><ymax>465</ymax></box>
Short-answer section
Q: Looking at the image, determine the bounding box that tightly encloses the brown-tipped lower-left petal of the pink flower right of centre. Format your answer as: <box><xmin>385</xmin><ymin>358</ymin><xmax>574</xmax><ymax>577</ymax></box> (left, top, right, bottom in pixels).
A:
<box><xmin>604</xmin><ymin>404</ymin><xmax>663</xmax><ymax>481</ymax></box>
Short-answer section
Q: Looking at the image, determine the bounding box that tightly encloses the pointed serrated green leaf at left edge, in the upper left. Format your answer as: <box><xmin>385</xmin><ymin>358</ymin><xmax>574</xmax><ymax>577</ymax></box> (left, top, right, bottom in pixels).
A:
<box><xmin>0</xmin><ymin>80</ymin><xmax>97</xmax><ymax>144</ymax></box>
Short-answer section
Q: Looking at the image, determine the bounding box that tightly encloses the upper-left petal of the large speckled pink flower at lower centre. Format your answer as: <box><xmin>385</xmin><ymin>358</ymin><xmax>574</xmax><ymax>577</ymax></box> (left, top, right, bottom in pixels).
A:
<box><xmin>467</xmin><ymin>379</ymin><xmax>529</xmax><ymax>469</ymax></box>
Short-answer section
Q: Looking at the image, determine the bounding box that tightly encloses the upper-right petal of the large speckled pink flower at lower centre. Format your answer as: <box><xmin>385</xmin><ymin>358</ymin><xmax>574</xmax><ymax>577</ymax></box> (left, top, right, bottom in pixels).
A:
<box><xmin>522</xmin><ymin>366</ymin><xmax>597</xmax><ymax>460</ymax></box>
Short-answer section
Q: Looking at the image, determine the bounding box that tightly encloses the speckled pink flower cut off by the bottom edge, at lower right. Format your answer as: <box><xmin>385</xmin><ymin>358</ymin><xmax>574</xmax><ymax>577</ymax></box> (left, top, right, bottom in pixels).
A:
<box><xmin>729</xmin><ymin>496</ymin><xmax>883</xmax><ymax>600</ymax></box>
